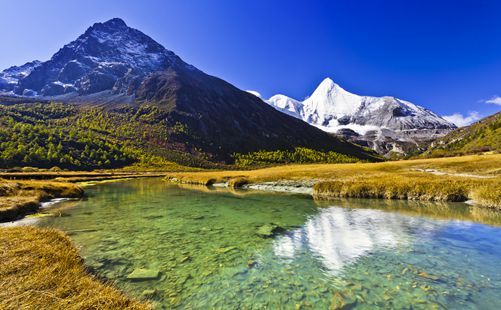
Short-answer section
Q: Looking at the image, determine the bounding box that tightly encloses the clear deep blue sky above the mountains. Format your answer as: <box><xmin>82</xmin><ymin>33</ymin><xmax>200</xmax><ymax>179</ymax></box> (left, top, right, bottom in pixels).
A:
<box><xmin>0</xmin><ymin>0</ymin><xmax>501</xmax><ymax>123</ymax></box>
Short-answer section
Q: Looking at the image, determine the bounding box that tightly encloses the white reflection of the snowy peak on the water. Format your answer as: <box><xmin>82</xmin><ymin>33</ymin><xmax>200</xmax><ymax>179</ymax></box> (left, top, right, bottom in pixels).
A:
<box><xmin>274</xmin><ymin>207</ymin><xmax>422</xmax><ymax>271</ymax></box>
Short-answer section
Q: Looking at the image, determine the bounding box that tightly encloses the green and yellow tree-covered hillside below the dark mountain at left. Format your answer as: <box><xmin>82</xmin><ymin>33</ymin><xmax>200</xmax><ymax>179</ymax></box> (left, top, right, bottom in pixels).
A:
<box><xmin>0</xmin><ymin>103</ymin><xmax>217</xmax><ymax>170</ymax></box>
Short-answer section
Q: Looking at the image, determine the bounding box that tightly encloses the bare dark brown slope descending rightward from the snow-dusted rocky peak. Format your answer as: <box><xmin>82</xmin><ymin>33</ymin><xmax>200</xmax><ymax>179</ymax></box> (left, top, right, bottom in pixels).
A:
<box><xmin>136</xmin><ymin>66</ymin><xmax>378</xmax><ymax>159</ymax></box>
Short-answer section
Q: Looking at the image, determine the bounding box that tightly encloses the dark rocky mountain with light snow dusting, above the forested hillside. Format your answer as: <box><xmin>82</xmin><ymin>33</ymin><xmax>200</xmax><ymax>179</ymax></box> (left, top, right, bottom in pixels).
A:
<box><xmin>3</xmin><ymin>18</ymin><xmax>374</xmax><ymax>161</ymax></box>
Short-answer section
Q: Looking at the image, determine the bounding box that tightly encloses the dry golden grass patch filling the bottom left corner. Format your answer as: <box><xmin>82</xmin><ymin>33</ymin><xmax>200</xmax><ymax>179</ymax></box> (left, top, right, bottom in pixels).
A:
<box><xmin>0</xmin><ymin>227</ymin><xmax>150</xmax><ymax>309</ymax></box>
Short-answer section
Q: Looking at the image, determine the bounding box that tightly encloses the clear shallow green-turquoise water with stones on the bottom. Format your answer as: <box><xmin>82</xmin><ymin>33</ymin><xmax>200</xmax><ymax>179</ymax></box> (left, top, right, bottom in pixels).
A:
<box><xmin>40</xmin><ymin>179</ymin><xmax>501</xmax><ymax>309</ymax></box>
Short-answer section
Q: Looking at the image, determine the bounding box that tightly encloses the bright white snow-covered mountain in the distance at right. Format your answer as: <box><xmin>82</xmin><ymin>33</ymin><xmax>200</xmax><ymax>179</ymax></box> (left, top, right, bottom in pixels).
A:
<box><xmin>266</xmin><ymin>78</ymin><xmax>456</xmax><ymax>155</ymax></box>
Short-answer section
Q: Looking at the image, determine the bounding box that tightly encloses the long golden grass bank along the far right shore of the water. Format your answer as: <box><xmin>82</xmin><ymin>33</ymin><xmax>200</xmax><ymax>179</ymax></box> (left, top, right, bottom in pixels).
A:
<box><xmin>167</xmin><ymin>154</ymin><xmax>501</xmax><ymax>208</ymax></box>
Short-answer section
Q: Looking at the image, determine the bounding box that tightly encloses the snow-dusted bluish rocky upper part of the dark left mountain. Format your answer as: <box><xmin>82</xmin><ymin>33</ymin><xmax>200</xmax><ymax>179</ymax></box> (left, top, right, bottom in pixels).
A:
<box><xmin>0</xmin><ymin>18</ymin><xmax>194</xmax><ymax>101</ymax></box>
